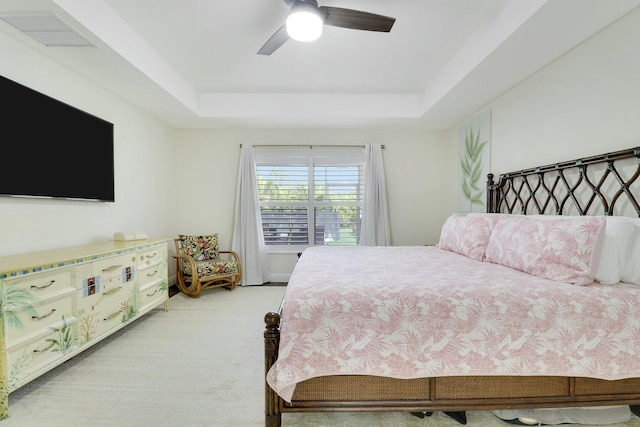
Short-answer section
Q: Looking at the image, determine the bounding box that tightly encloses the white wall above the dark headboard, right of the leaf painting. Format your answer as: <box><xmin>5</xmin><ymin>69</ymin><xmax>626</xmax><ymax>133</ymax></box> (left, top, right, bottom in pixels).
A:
<box><xmin>462</xmin><ymin>10</ymin><xmax>640</xmax><ymax>173</ymax></box>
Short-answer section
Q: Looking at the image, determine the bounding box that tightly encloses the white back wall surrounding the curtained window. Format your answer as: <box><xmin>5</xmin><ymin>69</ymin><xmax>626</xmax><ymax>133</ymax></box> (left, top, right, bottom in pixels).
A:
<box><xmin>177</xmin><ymin>129</ymin><xmax>457</xmax><ymax>281</ymax></box>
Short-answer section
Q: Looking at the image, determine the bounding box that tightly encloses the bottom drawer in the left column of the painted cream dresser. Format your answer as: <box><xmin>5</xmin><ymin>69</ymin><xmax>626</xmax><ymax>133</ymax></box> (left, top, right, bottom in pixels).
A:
<box><xmin>7</xmin><ymin>318</ymin><xmax>77</xmax><ymax>392</ymax></box>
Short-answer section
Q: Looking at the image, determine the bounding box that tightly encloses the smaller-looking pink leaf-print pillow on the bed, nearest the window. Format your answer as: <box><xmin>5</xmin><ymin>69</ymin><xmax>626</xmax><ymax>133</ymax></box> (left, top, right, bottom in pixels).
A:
<box><xmin>436</xmin><ymin>214</ymin><xmax>501</xmax><ymax>261</ymax></box>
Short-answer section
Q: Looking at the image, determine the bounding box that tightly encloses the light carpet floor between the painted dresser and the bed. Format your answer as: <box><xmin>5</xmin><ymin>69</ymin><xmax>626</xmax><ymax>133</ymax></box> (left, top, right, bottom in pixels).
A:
<box><xmin>5</xmin><ymin>286</ymin><xmax>640</xmax><ymax>427</ymax></box>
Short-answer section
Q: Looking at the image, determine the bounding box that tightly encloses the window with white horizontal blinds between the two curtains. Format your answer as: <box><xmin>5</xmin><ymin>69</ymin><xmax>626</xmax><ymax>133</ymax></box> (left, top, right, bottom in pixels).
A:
<box><xmin>256</xmin><ymin>147</ymin><xmax>364</xmax><ymax>249</ymax></box>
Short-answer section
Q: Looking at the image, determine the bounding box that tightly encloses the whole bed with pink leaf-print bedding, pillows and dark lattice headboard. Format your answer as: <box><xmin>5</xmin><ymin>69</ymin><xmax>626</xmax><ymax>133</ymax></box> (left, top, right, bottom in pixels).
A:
<box><xmin>264</xmin><ymin>148</ymin><xmax>640</xmax><ymax>427</ymax></box>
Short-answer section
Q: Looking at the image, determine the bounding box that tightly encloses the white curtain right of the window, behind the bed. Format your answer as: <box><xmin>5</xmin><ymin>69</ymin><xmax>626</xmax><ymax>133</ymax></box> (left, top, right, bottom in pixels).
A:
<box><xmin>360</xmin><ymin>144</ymin><xmax>391</xmax><ymax>246</ymax></box>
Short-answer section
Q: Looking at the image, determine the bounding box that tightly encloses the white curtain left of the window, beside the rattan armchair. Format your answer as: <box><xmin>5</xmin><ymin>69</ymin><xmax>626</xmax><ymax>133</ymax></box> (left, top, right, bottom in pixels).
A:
<box><xmin>231</xmin><ymin>144</ymin><xmax>271</xmax><ymax>286</ymax></box>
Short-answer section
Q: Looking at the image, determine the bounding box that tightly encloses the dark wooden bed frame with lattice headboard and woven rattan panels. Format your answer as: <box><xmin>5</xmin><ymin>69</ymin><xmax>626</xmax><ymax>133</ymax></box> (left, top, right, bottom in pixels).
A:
<box><xmin>264</xmin><ymin>147</ymin><xmax>640</xmax><ymax>427</ymax></box>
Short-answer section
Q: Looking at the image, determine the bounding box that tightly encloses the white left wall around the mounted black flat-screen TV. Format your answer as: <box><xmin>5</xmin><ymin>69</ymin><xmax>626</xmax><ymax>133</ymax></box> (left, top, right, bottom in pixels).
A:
<box><xmin>0</xmin><ymin>34</ymin><xmax>177</xmax><ymax>256</ymax></box>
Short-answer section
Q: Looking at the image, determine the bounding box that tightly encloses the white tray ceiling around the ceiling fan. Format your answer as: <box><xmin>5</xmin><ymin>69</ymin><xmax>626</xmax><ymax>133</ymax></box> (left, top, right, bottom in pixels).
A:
<box><xmin>0</xmin><ymin>0</ymin><xmax>640</xmax><ymax>129</ymax></box>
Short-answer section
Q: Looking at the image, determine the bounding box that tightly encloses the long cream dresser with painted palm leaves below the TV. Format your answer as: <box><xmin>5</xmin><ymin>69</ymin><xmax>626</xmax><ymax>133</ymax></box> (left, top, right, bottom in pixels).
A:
<box><xmin>0</xmin><ymin>239</ymin><xmax>169</xmax><ymax>419</ymax></box>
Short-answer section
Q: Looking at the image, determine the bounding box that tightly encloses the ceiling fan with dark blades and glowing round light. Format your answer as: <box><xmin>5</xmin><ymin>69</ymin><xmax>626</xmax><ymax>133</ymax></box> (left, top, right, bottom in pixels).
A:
<box><xmin>258</xmin><ymin>0</ymin><xmax>396</xmax><ymax>55</ymax></box>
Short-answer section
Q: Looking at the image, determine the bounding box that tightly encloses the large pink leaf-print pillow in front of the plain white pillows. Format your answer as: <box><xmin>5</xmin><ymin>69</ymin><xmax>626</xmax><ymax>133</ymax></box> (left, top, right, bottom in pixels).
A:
<box><xmin>485</xmin><ymin>216</ymin><xmax>605</xmax><ymax>285</ymax></box>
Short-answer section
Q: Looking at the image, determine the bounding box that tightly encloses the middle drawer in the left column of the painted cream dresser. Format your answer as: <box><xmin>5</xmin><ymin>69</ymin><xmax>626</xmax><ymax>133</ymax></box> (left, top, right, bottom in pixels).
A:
<box><xmin>5</xmin><ymin>290</ymin><xmax>75</xmax><ymax>347</ymax></box>
